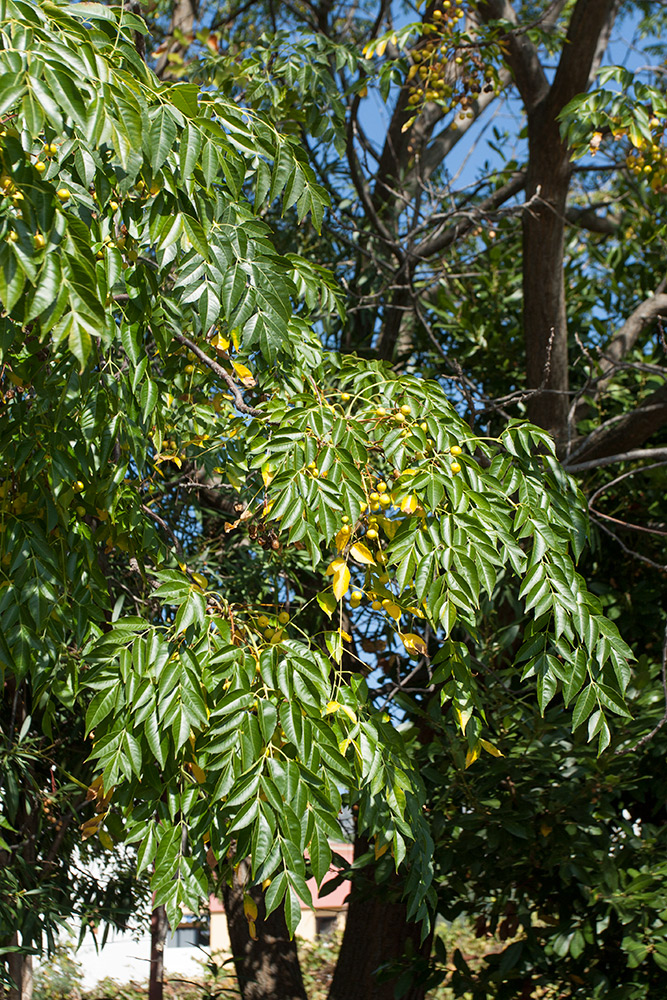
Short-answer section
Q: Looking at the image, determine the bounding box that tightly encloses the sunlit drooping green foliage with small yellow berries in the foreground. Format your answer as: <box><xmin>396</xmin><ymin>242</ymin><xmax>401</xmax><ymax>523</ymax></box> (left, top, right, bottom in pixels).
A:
<box><xmin>0</xmin><ymin>3</ymin><xmax>664</xmax><ymax>995</ymax></box>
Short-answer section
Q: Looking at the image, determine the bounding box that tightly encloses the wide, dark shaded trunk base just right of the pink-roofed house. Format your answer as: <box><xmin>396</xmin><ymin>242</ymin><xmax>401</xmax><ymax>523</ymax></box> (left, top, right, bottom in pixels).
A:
<box><xmin>329</xmin><ymin>837</ymin><xmax>433</xmax><ymax>1000</ymax></box>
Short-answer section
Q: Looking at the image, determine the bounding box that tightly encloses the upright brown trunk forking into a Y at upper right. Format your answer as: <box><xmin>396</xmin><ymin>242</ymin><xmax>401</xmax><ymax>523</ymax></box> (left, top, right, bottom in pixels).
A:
<box><xmin>480</xmin><ymin>0</ymin><xmax>619</xmax><ymax>446</ymax></box>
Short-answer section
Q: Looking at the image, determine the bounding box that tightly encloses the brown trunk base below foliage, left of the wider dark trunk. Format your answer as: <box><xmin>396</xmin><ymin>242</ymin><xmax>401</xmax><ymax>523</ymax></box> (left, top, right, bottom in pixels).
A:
<box><xmin>223</xmin><ymin>862</ymin><xmax>307</xmax><ymax>1000</ymax></box>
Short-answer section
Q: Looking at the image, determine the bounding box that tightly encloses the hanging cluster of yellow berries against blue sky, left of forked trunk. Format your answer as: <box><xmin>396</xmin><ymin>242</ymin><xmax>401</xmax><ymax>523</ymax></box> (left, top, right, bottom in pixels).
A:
<box><xmin>408</xmin><ymin>0</ymin><xmax>497</xmax><ymax>118</ymax></box>
